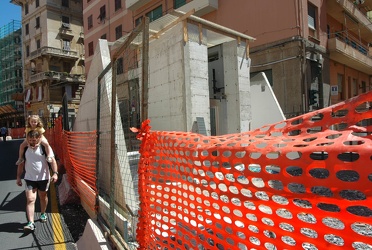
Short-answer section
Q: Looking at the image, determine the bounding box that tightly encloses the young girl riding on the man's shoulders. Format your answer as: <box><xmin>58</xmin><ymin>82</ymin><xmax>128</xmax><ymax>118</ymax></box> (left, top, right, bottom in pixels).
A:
<box><xmin>16</xmin><ymin>115</ymin><xmax>52</xmax><ymax>165</ymax></box>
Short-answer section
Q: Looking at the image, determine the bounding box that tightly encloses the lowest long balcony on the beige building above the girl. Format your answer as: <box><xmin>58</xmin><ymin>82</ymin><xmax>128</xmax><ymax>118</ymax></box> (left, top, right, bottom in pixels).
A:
<box><xmin>30</xmin><ymin>71</ymin><xmax>85</xmax><ymax>84</ymax></box>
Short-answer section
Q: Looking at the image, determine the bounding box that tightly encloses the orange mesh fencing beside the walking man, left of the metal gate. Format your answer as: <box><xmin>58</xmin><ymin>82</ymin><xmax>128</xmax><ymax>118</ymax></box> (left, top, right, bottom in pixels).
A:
<box><xmin>45</xmin><ymin>119</ymin><xmax>97</xmax><ymax>211</ymax></box>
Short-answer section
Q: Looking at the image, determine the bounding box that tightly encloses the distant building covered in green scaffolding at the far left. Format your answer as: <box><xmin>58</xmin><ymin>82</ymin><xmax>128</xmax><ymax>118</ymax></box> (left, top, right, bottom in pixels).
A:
<box><xmin>0</xmin><ymin>20</ymin><xmax>24</xmax><ymax>128</ymax></box>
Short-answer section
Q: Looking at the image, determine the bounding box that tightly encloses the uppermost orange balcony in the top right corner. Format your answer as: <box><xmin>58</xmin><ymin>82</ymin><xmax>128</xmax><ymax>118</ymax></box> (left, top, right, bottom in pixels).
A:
<box><xmin>326</xmin><ymin>0</ymin><xmax>372</xmax><ymax>41</ymax></box>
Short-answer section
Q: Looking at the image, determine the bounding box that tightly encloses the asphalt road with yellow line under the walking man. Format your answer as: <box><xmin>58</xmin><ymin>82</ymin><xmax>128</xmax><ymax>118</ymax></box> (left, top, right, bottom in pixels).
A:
<box><xmin>0</xmin><ymin>140</ymin><xmax>77</xmax><ymax>250</ymax></box>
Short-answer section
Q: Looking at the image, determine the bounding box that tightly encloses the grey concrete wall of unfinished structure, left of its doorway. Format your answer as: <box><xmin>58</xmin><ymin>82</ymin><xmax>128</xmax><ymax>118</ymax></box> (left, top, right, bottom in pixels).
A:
<box><xmin>148</xmin><ymin>24</ymin><xmax>210</xmax><ymax>131</ymax></box>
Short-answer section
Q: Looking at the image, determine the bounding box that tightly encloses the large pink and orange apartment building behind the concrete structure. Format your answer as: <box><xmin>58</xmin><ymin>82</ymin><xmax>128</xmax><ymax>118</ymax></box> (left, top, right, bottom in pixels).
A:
<box><xmin>83</xmin><ymin>0</ymin><xmax>372</xmax><ymax>117</ymax></box>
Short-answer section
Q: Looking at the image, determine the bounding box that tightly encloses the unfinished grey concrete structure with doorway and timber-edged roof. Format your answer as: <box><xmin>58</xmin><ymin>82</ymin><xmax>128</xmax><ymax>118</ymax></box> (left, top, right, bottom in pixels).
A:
<box><xmin>75</xmin><ymin>13</ymin><xmax>254</xmax><ymax>135</ymax></box>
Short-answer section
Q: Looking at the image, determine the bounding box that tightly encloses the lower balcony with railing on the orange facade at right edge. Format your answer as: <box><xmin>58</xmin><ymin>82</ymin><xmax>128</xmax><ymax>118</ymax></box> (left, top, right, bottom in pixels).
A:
<box><xmin>328</xmin><ymin>37</ymin><xmax>372</xmax><ymax>75</ymax></box>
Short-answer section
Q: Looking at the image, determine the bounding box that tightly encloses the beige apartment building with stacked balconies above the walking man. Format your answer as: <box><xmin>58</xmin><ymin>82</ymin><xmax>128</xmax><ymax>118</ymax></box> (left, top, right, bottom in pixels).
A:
<box><xmin>11</xmin><ymin>0</ymin><xmax>85</xmax><ymax>129</ymax></box>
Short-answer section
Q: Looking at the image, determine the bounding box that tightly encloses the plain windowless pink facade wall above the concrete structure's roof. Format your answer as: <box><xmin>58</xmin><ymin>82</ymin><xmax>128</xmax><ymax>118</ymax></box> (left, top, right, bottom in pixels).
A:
<box><xmin>203</xmin><ymin>0</ymin><xmax>300</xmax><ymax>46</ymax></box>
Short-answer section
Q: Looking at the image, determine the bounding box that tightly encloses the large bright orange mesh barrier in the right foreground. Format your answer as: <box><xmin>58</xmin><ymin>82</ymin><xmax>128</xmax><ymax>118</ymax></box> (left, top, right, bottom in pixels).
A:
<box><xmin>137</xmin><ymin>92</ymin><xmax>372</xmax><ymax>249</ymax></box>
